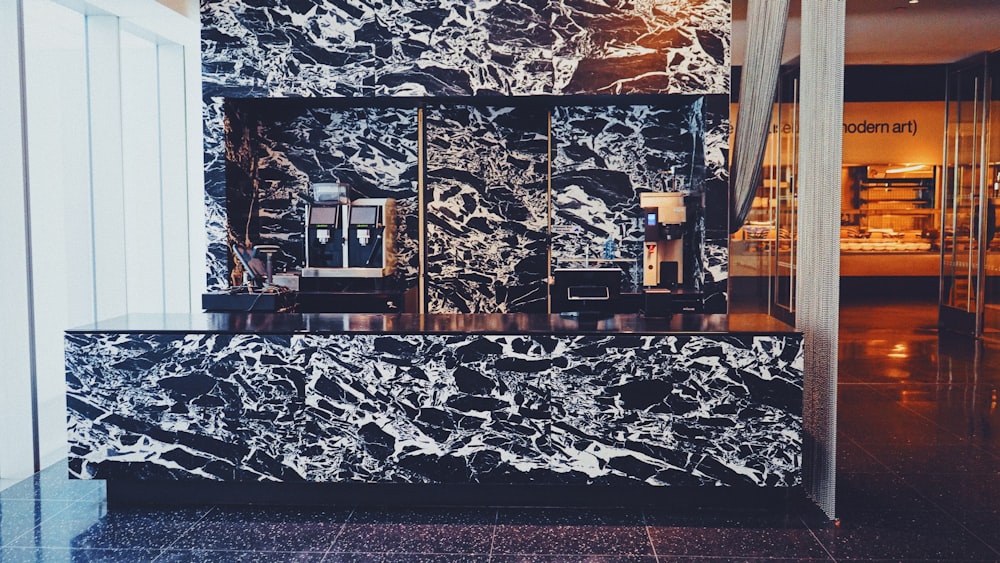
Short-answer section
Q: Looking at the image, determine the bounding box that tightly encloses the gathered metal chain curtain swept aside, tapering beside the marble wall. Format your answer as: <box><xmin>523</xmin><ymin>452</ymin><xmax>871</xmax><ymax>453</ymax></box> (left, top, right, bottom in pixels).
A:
<box><xmin>729</xmin><ymin>0</ymin><xmax>789</xmax><ymax>232</ymax></box>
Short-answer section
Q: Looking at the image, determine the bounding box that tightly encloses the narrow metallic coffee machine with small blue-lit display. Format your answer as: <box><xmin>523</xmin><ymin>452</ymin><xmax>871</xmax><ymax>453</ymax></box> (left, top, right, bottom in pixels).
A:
<box><xmin>639</xmin><ymin>192</ymin><xmax>688</xmax><ymax>289</ymax></box>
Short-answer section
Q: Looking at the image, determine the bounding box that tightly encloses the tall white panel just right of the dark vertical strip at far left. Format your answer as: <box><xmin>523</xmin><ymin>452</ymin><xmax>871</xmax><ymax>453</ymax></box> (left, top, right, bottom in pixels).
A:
<box><xmin>24</xmin><ymin>0</ymin><xmax>94</xmax><ymax>465</ymax></box>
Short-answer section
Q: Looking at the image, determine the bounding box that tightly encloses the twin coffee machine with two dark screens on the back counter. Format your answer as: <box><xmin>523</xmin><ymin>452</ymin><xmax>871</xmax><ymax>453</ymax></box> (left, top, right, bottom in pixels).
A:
<box><xmin>301</xmin><ymin>184</ymin><xmax>396</xmax><ymax>278</ymax></box>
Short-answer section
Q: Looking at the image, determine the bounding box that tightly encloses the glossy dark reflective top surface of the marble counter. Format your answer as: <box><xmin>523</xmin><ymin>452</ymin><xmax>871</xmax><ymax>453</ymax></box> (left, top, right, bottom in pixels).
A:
<box><xmin>66</xmin><ymin>312</ymin><xmax>795</xmax><ymax>334</ymax></box>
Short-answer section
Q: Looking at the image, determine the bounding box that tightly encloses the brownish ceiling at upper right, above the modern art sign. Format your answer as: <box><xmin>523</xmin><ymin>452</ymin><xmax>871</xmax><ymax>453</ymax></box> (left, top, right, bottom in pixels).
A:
<box><xmin>732</xmin><ymin>0</ymin><xmax>1000</xmax><ymax>66</ymax></box>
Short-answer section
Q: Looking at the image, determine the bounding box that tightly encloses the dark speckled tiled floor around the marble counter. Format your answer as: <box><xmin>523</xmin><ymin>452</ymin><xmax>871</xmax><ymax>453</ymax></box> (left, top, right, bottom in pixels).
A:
<box><xmin>0</xmin><ymin>303</ymin><xmax>1000</xmax><ymax>563</ymax></box>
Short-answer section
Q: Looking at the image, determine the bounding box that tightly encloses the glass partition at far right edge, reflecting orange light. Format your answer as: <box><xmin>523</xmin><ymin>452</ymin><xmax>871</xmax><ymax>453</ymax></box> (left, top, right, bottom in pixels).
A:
<box><xmin>939</xmin><ymin>53</ymin><xmax>1000</xmax><ymax>339</ymax></box>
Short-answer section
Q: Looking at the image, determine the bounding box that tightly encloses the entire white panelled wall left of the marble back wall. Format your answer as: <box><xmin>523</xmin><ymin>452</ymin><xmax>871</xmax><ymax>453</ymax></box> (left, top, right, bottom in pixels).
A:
<box><xmin>0</xmin><ymin>0</ymin><xmax>205</xmax><ymax>479</ymax></box>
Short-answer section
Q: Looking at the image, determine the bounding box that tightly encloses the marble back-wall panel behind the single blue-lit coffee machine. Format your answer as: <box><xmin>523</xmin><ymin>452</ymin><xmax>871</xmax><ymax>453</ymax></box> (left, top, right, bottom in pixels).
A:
<box><xmin>552</xmin><ymin>101</ymin><xmax>705</xmax><ymax>292</ymax></box>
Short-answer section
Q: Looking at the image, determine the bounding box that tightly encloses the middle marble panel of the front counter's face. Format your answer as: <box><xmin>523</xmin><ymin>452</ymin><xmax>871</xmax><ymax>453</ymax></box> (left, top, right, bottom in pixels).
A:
<box><xmin>297</xmin><ymin>335</ymin><xmax>551</xmax><ymax>483</ymax></box>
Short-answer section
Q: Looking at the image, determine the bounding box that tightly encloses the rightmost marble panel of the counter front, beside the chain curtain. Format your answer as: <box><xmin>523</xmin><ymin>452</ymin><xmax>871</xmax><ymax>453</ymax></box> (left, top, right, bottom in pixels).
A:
<box><xmin>549</xmin><ymin>335</ymin><xmax>802</xmax><ymax>486</ymax></box>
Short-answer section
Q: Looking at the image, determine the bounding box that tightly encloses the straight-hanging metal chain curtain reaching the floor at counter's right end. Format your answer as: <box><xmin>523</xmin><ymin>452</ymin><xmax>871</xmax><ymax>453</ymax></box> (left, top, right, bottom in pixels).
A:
<box><xmin>795</xmin><ymin>0</ymin><xmax>846</xmax><ymax>519</ymax></box>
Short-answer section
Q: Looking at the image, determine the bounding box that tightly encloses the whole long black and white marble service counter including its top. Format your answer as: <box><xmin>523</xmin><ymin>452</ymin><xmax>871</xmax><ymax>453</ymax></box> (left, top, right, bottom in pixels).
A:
<box><xmin>65</xmin><ymin>314</ymin><xmax>803</xmax><ymax>502</ymax></box>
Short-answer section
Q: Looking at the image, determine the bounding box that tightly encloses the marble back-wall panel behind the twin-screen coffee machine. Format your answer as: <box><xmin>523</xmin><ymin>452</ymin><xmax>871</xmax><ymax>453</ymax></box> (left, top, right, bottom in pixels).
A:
<box><xmin>227</xmin><ymin>100</ymin><xmax>419</xmax><ymax>287</ymax></box>
